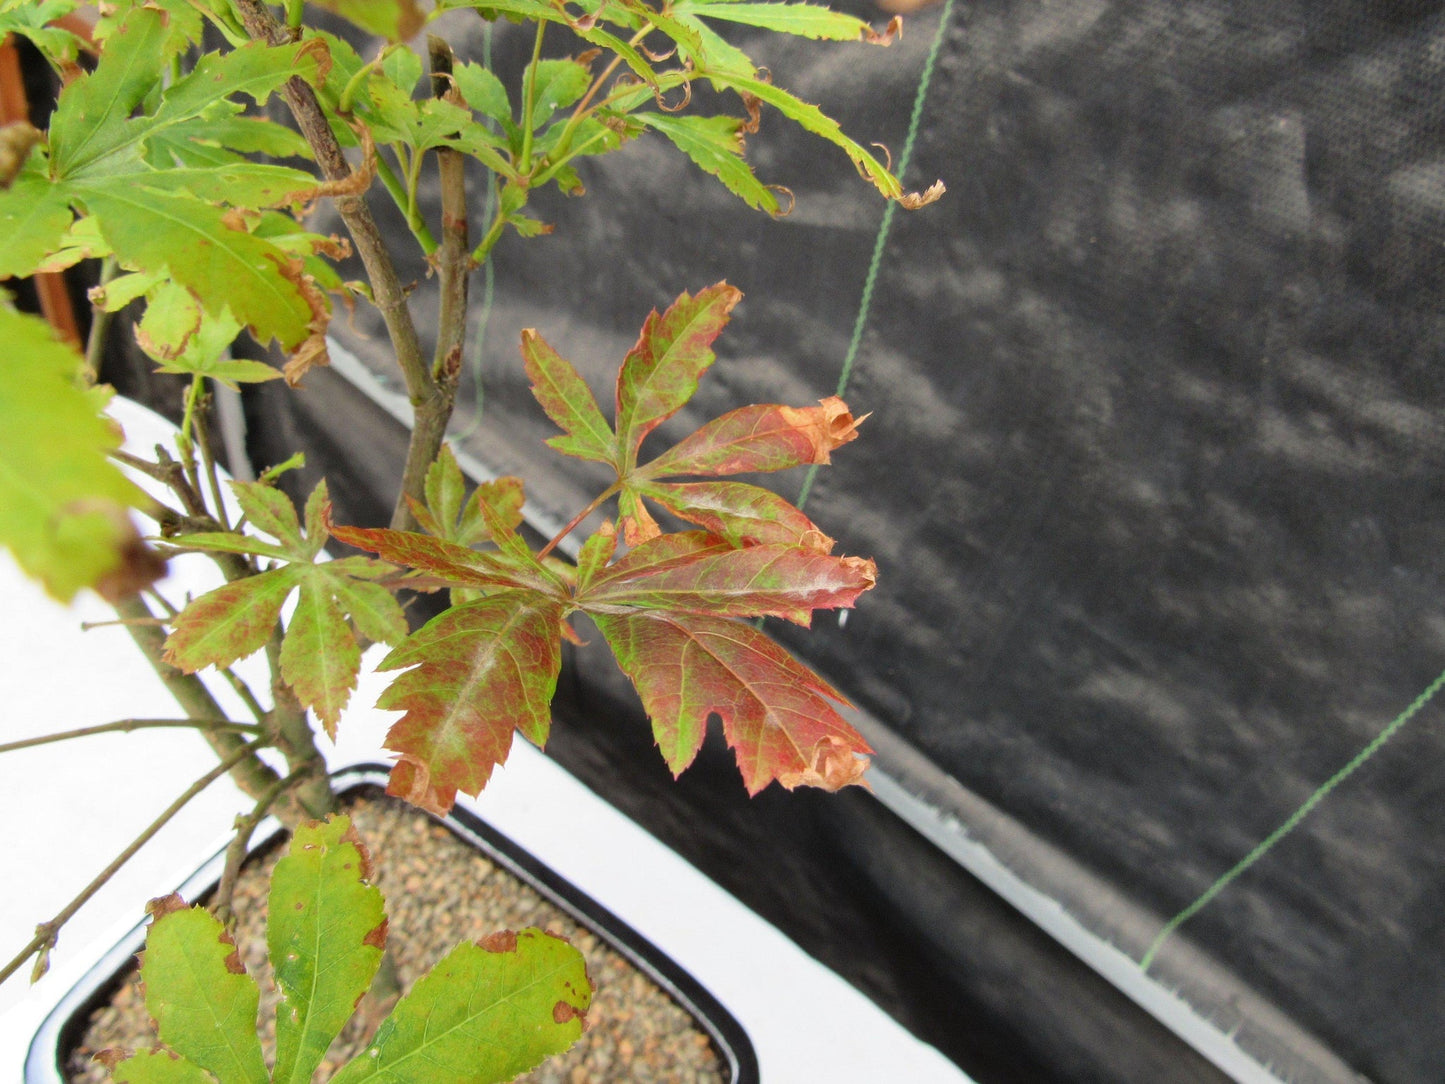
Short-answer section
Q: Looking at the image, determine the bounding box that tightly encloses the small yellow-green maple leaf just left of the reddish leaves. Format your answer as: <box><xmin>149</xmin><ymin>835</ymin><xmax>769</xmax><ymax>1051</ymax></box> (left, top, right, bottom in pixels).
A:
<box><xmin>165</xmin><ymin>481</ymin><xmax>406</xmax><ymax>737</ymax></box>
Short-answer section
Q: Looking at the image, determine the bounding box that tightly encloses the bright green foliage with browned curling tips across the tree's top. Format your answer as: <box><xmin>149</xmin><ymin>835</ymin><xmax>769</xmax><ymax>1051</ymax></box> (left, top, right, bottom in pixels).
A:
<box><xmin>0</xmin><ymin>0</ymin><xmax>936</xmax><ymax>597</ymax></box>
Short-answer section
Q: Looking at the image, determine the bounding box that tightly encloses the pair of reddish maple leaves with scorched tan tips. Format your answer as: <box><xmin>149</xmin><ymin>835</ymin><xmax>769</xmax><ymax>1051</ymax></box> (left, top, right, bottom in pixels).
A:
<box><xmin>332</xmin><ymin>283</ymin><xmax>876</xmax><ymax>811</ymax></box>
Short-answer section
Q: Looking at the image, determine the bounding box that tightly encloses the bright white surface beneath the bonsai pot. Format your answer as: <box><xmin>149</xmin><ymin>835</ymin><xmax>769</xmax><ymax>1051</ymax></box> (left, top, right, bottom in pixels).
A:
<box><xmin>0</xmin><ymin>403</ymin><xmax>967</xmax><ymax>1084</ymax></box>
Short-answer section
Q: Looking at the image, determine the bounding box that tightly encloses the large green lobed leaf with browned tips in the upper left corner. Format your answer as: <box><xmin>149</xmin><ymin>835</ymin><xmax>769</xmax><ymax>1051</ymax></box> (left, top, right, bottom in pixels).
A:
<box><xmin>0</xmin><ymin>4</ymin><xmax>328</xmax><ymax>352</ymax></box>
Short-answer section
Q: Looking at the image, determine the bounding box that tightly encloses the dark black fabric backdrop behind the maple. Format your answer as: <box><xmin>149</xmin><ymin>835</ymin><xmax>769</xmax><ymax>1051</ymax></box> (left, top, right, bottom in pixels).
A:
<box><xmin>96</xmin><ymin>0</ymin><xmax>1445</xmax><ymax>1084</ymax></box>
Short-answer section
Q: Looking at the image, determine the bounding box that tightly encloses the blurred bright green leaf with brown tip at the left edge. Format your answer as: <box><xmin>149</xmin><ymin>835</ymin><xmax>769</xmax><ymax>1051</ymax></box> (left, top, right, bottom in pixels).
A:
<box><xmin>0</xmin><ymin>301</ymin><xmax>162</xmax><ymax>601</ymax></box>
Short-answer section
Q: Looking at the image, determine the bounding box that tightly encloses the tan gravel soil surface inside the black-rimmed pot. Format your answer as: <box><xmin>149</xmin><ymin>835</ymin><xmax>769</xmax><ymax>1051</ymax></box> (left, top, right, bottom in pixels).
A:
<box><xmin>66</xmin><ymin>798</ymin><xmax>727</xmax><ymax>1084</ymax></box>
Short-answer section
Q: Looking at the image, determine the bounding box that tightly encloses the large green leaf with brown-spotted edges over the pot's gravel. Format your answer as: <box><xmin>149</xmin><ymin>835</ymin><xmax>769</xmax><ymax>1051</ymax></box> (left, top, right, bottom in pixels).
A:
<box><xmin>98</xmin><ymin>815</ymin><xmax>592</xmax><ymax>1084</ymax></box>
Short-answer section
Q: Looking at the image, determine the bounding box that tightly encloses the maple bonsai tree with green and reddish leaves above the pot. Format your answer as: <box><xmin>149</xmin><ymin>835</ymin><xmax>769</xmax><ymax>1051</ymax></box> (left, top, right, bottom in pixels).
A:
<box><xmin>0</xmin><ymin>0</ymin><xmax>942</xmax><ymax>1078</ymax></box>
